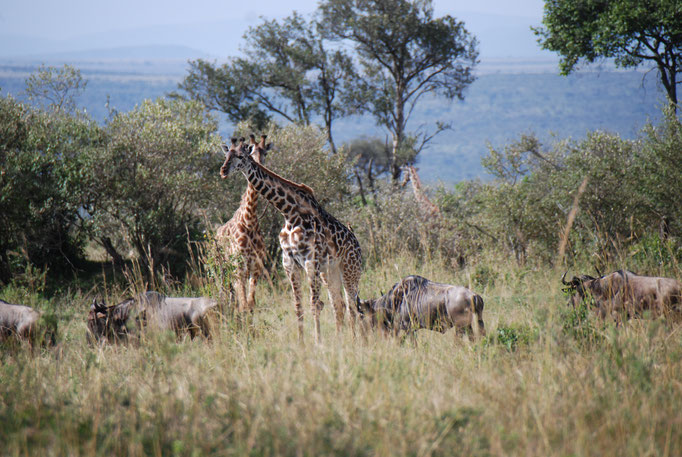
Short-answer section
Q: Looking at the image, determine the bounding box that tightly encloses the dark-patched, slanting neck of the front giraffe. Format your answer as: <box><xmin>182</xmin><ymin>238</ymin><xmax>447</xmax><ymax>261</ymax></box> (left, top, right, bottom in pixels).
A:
<box><xmin>243</xmin><ymin>160</ymin><xmax>311</xmax><ymax>220</ymax></box>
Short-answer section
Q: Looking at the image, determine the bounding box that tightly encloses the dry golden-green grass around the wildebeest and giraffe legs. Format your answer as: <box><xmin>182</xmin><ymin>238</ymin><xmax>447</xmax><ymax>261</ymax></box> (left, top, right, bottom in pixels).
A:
<box><xmin>0</xmin><ymin>256</ymin><xmax>682</xmax><ymax>456</ymax></box>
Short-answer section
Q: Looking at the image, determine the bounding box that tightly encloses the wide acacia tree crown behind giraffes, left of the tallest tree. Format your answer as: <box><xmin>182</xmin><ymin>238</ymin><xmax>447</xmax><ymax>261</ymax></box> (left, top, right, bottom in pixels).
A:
<box><xmin>180</xmin><ymin>12</ymin><xmax>354</xmax><ymax>152</ymax></box>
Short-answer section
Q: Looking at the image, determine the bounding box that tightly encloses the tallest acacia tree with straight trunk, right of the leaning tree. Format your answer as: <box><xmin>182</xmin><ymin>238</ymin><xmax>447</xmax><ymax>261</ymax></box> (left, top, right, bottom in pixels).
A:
<box><xmin>320</xmin><ymin>0</ymin><xmax>478</xmax><ymax>182</ymax></box>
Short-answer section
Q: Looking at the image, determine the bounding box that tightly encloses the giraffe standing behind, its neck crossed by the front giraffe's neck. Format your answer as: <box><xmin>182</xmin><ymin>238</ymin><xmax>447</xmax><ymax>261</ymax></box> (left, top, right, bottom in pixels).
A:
<box><xmin>216</xmin><ymin>135</ymin><xmax>270</xmax><ymax>312</ymax></box>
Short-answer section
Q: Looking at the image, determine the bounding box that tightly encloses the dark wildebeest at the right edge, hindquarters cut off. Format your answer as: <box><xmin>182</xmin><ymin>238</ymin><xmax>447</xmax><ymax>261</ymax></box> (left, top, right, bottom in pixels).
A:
<box><xmin>561</xmin><ymin>270</ymin><xmax>682</xmax><ymax>322</ymax></box>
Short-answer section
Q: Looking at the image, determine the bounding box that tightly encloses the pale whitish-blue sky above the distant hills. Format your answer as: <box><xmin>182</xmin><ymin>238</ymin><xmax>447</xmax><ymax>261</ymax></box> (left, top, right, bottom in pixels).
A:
<box><xmin>0</xmin><ymin>0</ymin><xmax>544</xmax><ymax>52</ymax></box>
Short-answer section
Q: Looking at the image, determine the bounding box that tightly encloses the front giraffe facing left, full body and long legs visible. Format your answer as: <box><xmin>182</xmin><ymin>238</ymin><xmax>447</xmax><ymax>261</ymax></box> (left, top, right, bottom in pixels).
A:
<box><xmin>220</xmin><ymin>138</ymin><xmax>362</xmax><ymax>344</ymax></box>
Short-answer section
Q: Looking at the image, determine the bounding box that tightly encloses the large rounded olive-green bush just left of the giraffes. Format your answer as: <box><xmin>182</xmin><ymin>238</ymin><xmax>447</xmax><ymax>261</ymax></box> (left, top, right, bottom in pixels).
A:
<box><xmin>83</xmin><ymin>99</ymin><xmax>220</xmax><ymax>271</ymax></box>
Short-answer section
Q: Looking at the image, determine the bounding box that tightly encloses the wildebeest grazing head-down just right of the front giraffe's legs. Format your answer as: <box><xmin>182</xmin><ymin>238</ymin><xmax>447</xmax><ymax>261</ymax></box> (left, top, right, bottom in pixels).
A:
<box><xmin>357</xmin><ymin>275</ymin><xmax>485</xmax><ymax>336</ymax></box>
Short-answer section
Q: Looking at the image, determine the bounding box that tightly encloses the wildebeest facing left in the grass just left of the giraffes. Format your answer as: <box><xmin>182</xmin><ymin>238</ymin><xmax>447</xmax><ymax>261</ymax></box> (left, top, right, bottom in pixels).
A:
<box><xmin>88</xmin><ymin>291</ymin><xmax>217</xmax><ymax>340</ymax></box>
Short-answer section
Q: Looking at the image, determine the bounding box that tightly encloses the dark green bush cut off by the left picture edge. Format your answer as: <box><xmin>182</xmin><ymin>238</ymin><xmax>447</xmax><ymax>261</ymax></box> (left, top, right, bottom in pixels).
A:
<box><xmin>0</xmin><ymin>97</ymin><xmax>102</xmax><ymax>282</ymax></box>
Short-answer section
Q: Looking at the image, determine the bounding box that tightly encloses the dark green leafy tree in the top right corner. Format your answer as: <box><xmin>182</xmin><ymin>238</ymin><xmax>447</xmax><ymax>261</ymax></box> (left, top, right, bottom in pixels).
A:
<box><xmin>533</xmin><ymin>0</ymin><xmax>682</xmax><ymax>109</ymax></box>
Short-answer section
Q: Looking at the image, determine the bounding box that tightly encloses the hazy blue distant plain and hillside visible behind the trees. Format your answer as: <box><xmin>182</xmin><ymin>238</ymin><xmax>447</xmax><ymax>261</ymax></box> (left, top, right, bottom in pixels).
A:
<box><xmin>0</xmin><ymin>57</ymin><xmax>663</xmax><ymax>183</ymax></box>
